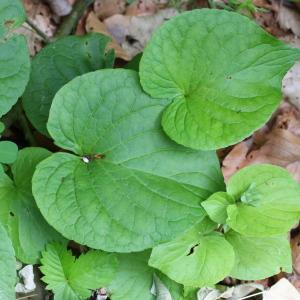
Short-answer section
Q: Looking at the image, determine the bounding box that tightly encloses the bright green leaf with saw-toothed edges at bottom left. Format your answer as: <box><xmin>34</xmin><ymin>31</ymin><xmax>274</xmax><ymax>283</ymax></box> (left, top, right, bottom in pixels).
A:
<box><xmin>40</xmin><ymin>244</ymin><xmax>118</xmax><ymax>300</ymax></box>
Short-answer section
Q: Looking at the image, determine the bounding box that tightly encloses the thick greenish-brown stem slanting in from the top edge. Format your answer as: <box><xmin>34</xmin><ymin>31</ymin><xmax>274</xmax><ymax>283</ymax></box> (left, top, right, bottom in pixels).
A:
<box><xmin>55</xmin><ymin>0</ymin><xmax>94</xmax><ymax>39</ymax></box>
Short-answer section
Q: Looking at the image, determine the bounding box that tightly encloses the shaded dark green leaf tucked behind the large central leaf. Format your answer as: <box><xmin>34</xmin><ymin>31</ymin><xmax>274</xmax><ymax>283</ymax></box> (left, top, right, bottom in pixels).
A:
<box><xmin>22</xmin><ymin>33</ymin><xmax>114</xmax><ymax>135</ymax></box>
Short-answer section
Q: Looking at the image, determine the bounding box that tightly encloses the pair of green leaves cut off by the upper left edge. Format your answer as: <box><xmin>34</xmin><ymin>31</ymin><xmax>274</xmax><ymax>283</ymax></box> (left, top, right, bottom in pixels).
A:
<box><xmin>0</xmin><ymin>0</ymin><xmax>30</xmax><ymax>117</ymax></box>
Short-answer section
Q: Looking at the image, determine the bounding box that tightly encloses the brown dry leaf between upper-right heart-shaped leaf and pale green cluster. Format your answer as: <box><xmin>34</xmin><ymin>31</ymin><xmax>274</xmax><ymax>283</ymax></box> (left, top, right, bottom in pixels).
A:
<box><xmin>222</xmin><ymin>103</ymin><xmax>300</xmax><ymax>180</ymax></box>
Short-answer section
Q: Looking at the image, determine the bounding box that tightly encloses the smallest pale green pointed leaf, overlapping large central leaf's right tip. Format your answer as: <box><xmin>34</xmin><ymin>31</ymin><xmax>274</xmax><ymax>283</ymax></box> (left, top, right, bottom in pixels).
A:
<box><xmin>201</xmin><ymin>192</ymin><xmax>235</xmax><ymax>224</ymax></box>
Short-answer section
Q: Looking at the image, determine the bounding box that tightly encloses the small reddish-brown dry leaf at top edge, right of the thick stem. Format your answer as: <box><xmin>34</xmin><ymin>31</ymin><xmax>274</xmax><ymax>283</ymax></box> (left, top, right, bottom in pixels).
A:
<box><xmin>94</xmin><ymin>0</ymin><xmax>126</xmax><ymax>20</ymax></box>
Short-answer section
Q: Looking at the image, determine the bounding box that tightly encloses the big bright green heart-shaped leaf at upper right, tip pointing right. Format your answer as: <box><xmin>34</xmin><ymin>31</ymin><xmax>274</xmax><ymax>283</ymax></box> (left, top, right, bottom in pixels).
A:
<box><xmin>140</xmin><ymin>9</ymin><xmax>300</xmax><ymax>149</ymax></box>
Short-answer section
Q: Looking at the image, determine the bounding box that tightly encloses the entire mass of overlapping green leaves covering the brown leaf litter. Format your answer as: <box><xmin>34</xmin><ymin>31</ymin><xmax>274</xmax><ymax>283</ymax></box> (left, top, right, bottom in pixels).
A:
<box><xmin>0</xmin><ymin>5</ymin><xmax>300</xmax><ymax>300</ymax></box>
